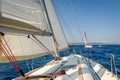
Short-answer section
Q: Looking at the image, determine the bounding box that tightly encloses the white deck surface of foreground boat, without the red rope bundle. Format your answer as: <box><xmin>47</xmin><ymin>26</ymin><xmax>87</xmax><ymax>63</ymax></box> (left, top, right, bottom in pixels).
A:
<box><xmin>14</xmin><ymin>55</ymin><xmax>117</xmax><ymax>80</ymax></box>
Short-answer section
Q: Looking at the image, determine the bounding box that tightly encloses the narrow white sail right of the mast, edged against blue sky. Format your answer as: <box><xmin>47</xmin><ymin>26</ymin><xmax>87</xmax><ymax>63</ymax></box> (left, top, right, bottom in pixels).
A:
<box><xmin>45</xmin><ymin>0</ymin><xmax>68</xmax><ymax>49</ymax></box>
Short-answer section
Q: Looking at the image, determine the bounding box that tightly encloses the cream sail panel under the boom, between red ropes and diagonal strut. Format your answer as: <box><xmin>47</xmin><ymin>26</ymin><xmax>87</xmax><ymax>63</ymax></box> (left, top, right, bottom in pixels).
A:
<box><xmin>0</xmin><ymin>35</ymin><xmax>52</xmax><ymax>61</ymax></box>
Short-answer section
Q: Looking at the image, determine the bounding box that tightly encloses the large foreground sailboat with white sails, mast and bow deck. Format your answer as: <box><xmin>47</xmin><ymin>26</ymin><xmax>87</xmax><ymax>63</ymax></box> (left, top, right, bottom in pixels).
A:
<box><xmin>0</xmin><ymin>0</ymin><xmax>118</xmax><ymax>80</ymax></box>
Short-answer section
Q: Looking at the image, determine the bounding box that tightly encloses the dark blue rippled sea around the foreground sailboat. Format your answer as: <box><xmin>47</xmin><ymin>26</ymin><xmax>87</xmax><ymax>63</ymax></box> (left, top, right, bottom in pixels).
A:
<box><xmin>0</xmin><ymin>45</ymin><xmax>120</xmax><ymax>80</ymax></box>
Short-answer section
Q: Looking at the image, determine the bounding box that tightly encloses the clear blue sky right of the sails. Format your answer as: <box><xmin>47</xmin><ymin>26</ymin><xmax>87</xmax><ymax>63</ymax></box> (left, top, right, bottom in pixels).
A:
<box><xmin>54</xmin><ymin>0</ymin><xmax>120</xmax><ymax>44</ymax></box>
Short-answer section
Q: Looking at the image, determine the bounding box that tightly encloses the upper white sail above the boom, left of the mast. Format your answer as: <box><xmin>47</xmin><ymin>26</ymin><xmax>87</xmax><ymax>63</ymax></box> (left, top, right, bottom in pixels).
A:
<box><xmin>0</xmin><ymin>0</ymin><xmax>50</xmax><ymax>32</ymax></box>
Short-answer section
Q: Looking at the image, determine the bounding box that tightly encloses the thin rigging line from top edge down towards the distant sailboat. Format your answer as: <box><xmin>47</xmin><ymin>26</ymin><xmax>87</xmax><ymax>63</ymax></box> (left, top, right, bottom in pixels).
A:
<box><xmin>69</xmin><ymin>0</ymin><xmax>84</xmax><ymax>42</ymax></box>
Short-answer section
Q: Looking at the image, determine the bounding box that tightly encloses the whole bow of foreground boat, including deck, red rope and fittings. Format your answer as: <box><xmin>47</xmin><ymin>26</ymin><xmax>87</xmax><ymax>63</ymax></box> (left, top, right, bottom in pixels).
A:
<box><xmin>14</xmin><ymin>54</ymin><xmax>119</xmax><ymax>80</ymax></box>
